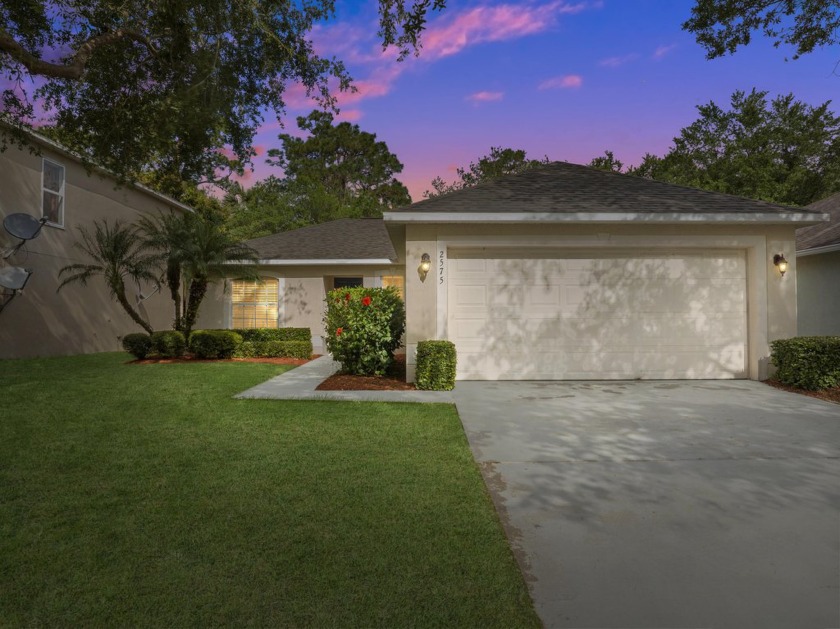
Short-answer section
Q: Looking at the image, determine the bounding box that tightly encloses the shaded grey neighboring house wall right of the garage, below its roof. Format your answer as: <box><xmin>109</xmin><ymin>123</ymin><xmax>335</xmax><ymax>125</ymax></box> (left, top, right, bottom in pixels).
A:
<box><xmin>796</xmin><ymin>251</ymin><xmax>840</xmax><ymax>336</ymax></box>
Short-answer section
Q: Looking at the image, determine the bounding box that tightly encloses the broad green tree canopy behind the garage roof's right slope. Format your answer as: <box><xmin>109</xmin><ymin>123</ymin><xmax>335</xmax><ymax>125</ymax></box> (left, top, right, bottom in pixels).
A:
<box><xmin>596</xmin><ymin>90</ymin><xmax>840</xmax><ymax>205</ymax></box>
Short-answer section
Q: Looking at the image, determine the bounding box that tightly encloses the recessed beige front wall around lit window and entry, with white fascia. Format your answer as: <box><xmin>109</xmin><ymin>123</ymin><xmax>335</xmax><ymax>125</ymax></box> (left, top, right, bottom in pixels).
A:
<box><xmin>198</xmin><ymin>265</ymin><xmax>405</xmax><ymax>354</ymax></box>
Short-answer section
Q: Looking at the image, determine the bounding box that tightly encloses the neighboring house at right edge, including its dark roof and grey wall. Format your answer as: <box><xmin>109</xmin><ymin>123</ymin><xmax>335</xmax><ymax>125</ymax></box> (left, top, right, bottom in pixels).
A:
<box><xmin>796</xmin><ymin>193</ymin><xmax>840</xmax><ymax>336</ymax></box>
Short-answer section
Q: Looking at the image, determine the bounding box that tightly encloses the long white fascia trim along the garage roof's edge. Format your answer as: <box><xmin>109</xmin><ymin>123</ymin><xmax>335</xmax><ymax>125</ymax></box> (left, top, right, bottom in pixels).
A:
<box><xmin>383</xmin><ymin>212</ymin><xmax>829</xmax><ymax>225</ymax></box>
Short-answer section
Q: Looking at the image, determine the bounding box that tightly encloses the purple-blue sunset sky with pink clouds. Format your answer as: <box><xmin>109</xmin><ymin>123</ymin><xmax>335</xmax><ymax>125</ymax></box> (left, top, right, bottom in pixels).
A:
<box><xmin>247</xmin><ymin>0</ymin><xmax>840</xmax><ymax>201</ymax></box>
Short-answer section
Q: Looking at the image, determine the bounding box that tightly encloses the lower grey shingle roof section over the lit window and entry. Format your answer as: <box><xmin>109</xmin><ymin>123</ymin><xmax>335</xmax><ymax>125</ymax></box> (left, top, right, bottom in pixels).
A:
<box><xmin>246</xmin><ymin>218</ymin><xmax>397</xmax><ymax>260</ymax></box>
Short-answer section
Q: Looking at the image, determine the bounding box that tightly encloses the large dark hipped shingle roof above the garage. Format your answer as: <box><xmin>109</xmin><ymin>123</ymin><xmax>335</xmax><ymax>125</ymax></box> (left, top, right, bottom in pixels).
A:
<box><xmin>389</xmin><ymin>162</ymin><xmax>824</xmax><ymax>219</ymax></box>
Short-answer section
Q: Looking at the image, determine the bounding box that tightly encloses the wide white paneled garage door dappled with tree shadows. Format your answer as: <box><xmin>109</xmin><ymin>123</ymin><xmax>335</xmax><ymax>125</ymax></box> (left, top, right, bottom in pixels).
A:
<box><xmin>447</xmin><ymin>250</ymin><xmax>747</xmax><ymax>380</ymax></box>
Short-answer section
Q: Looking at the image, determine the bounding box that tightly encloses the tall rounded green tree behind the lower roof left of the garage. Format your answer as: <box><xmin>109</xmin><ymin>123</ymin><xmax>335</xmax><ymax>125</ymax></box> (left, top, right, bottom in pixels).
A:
<box><xmin>268</xmin><ymin>111</ymin><xmax>411</xmax><ymax>222</ymax></box>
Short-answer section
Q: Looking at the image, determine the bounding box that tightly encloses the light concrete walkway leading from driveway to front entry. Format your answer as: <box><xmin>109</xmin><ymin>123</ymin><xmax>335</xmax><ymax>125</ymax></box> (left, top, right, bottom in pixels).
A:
<box><xmin>236</xmin><ymin>355</ymin><xmax>454</xmax><ymax>404</ymax></box>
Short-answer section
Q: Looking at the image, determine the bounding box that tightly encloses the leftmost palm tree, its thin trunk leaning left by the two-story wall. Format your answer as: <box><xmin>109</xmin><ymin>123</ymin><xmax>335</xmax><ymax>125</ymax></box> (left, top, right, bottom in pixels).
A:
<box><xmin>57</xmin><ymin>220</ymin><xmax>160</xmax><ymax>334</ymax></box>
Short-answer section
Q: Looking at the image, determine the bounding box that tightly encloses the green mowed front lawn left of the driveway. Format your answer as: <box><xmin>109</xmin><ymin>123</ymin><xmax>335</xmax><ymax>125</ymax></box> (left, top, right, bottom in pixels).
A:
<box><xmin>0</xmin><ymin>354</ymin><xmax>539</xmax><ymax>627</ymax></box>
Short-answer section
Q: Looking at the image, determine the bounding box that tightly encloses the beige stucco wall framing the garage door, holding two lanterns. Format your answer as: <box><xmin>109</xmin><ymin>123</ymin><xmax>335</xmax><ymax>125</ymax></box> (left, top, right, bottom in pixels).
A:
<box><xmin>405</xmin><ymin>223</ymin><xmax>797</xmax><ymax>380</ymax></box>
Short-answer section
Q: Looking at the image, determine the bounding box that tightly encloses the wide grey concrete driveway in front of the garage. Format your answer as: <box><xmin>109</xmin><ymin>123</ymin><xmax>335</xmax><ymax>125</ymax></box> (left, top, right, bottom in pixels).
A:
<box><xmin>454</xmin><ymin>381</ymin><xmax>840</xmax><ymax>629</ymax></box>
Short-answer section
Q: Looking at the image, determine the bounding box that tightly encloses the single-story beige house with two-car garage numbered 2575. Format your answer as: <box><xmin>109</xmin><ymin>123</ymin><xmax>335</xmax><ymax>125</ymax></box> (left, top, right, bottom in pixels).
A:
<box><xmin>201</xmin><ymin>163</ymin><xmax>828</xmax><ymax>380</ymax></box>
